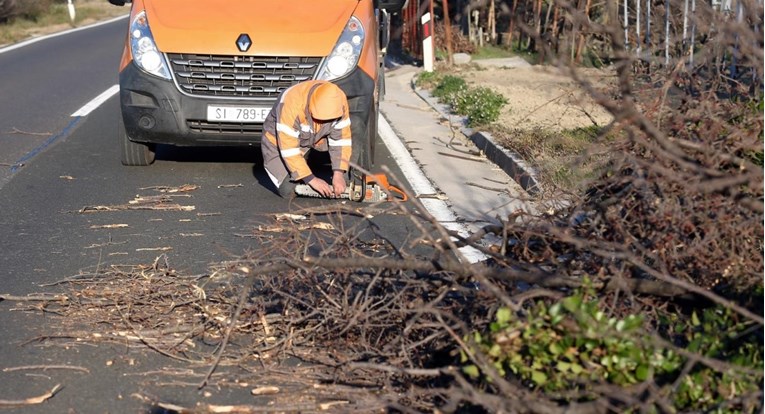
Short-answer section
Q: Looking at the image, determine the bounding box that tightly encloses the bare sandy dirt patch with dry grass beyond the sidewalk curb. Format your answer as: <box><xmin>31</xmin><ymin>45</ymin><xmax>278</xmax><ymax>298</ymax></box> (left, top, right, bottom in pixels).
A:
<box><xmin>436</xmin><ymin>64</ymin><xmax>615</xmax><ymax>195</ymax></box>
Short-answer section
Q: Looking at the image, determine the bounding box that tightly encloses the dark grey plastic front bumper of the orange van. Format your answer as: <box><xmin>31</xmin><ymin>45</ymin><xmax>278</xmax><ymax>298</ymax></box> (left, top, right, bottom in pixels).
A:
<box><xmin>119</xmin><ymin>63</ymin><xmax>376</xmax><ymax>146</ymax></box>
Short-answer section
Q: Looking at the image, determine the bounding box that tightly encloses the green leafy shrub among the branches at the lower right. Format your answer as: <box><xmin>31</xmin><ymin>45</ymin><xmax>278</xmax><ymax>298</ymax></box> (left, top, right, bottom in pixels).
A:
<box><xmin>462</xmin><ymin>288</ymin><xmax>763</xmax><ymax>411</ymax></box>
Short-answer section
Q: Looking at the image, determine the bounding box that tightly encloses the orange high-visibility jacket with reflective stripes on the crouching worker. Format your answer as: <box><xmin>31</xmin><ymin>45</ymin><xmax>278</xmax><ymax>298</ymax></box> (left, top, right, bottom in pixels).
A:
<box><xmin>262</xmin><ymin>80</ymin><xmax>351</xmax><ymax>180</ymax></box>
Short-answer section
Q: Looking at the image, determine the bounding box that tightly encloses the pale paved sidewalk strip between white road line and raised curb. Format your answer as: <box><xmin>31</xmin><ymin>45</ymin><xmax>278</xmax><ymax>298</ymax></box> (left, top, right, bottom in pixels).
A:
<box><xmin>381</xmin><ymin>65</ymin><xmax>529</xmax><ymax>231</ymax></box>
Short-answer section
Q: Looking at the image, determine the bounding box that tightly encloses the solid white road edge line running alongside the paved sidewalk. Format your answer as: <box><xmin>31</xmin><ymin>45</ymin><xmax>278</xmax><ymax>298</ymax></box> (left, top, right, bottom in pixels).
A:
<box><xmin>377</xmin><ymin>115</ymin><xmax>487</xmax><ymax>263</ymax></box>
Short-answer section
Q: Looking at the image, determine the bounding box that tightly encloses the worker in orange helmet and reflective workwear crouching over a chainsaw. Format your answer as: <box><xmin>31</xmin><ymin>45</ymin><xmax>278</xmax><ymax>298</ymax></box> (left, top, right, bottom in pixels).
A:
<box><xmin>260</xmin><ymin>80</ymin><xmax>351</xmax><ymax>197</ymax></box>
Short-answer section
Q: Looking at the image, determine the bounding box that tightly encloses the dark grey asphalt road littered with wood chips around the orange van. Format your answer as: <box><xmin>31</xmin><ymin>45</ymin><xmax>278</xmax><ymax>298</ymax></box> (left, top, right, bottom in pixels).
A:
<box><xmin>0</xmin><ymin>15</ymin><xmax>413</xmax><ymax>413</ymax></box>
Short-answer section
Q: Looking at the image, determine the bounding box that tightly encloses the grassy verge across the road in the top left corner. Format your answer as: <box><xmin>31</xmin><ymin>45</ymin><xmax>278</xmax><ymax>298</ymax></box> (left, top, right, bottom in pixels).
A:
<box><xmin>0</xmin><ymin>0</ymin><xmax>128</xmax><ymax>46</ymax></box>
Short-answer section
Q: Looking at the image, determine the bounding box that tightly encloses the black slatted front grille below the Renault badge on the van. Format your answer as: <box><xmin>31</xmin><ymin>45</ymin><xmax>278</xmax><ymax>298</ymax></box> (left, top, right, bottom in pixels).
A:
<box><xmin>167</xmin><ymin>53</ymin><xmax>321</xmax><ymax>100</ymax></box>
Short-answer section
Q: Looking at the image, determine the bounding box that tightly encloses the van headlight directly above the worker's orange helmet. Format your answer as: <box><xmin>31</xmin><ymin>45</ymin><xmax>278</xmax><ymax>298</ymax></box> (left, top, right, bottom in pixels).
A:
<box><xmin>316</xmin><ymin>17</ymin><xmax>364</xmax><ymax>80</ymax></box>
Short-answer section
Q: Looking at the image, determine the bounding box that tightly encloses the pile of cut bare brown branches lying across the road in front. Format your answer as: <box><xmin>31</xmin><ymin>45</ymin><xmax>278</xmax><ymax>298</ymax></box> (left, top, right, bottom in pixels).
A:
<box><xmin>3</xmin><ymin>175</ymin><xmax>761</xmax><ymax>412</ymax></box>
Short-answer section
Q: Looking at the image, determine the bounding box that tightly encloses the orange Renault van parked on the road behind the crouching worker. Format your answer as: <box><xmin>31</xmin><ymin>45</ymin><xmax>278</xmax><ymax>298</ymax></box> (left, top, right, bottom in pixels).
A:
<box><xmin>109</xmin><ymin>0</ymin><xmax>406</xmax><ymax>168</ymax></box>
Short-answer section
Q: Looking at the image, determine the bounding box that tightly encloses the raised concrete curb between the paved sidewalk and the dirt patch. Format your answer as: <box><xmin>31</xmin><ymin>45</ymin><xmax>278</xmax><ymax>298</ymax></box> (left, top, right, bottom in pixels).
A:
<box><xmin>410</xmin><ymin>77</ymin><xmax>542</xmax><ymax>195</ymax></box>
